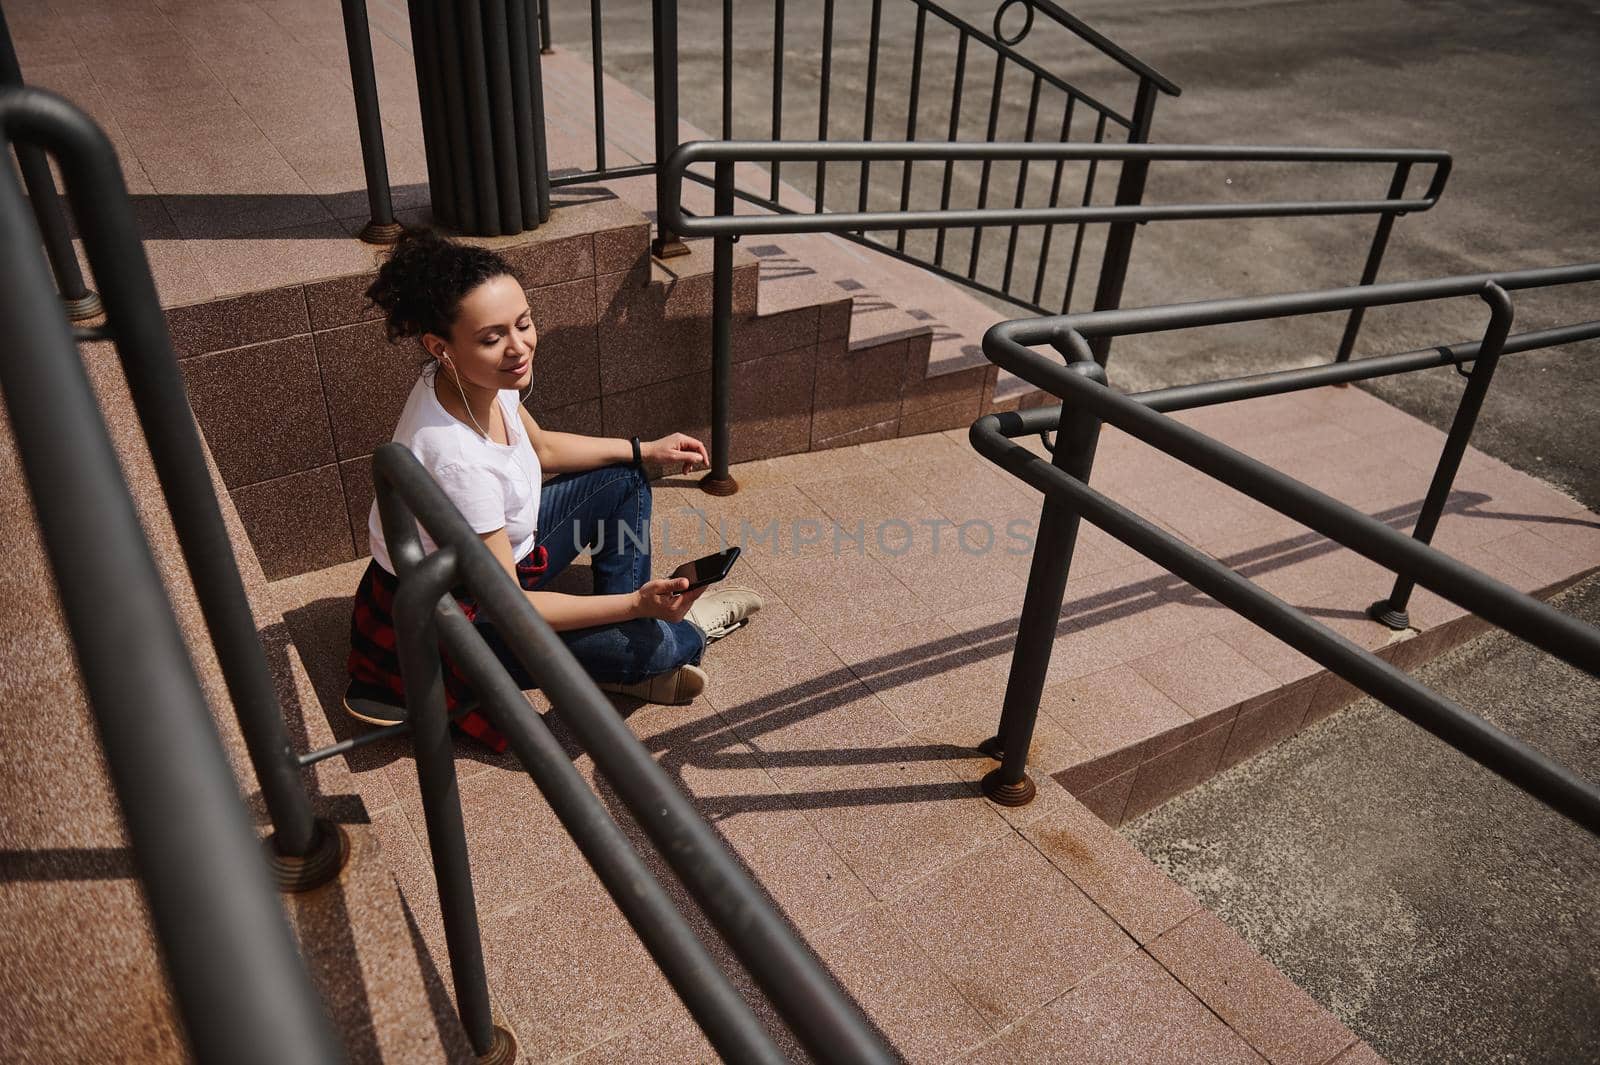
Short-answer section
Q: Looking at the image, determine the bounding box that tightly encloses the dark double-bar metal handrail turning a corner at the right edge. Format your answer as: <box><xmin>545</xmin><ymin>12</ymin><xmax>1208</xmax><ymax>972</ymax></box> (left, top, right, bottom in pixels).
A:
<box><xmin>970</xmin><ymin>264</ymin><xmax>1600</xmax><ymax>835</ymax></box>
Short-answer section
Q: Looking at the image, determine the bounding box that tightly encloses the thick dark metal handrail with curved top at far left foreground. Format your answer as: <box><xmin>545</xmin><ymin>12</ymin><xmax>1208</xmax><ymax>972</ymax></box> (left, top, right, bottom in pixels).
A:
<box><xmin>0</xmin><ymin>90</ymin><xmax>342</xmax><ymax>1063</ymax></box>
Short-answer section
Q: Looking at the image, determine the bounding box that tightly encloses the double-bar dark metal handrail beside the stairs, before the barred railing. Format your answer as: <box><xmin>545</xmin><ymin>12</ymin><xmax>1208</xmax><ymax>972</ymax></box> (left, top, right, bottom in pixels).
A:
<box><xmin>661</xmin><ymin>141</ymin><xmax>1451</xmax><ymax>494</ymax></box>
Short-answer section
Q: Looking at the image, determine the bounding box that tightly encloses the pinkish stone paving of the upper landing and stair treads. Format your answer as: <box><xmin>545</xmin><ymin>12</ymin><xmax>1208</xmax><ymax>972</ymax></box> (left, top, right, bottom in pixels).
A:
<box><xmin>18</xmin><ymin>0</ymin><xmax>1030</xmax><ymax>398</ymax></box>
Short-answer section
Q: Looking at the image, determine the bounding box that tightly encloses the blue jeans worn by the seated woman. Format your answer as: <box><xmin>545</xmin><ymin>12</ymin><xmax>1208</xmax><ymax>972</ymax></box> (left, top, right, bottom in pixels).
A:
<box><xmin>478</xmin><ymin>465</ymin><xmax>706</xmax><ymax>688</ymax></box>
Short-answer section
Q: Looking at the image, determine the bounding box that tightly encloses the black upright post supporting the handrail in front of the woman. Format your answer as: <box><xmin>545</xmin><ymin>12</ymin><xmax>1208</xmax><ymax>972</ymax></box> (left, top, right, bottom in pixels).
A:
<box><xmin>379</xmin><ymin>543</ymin><xmax>517</xmax><ymax>1063</ymax></box>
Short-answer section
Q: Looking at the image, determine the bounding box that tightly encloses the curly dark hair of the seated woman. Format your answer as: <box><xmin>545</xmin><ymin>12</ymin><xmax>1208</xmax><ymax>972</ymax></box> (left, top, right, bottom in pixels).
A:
<box><xmin>366</xmin><ymin>229</ymin><xmax>512</xmax><ymax>344</ymax></box>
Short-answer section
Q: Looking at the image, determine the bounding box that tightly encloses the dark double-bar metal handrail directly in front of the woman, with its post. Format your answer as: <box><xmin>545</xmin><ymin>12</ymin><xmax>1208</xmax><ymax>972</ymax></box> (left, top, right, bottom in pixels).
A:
<box><xmin>373</xmin><ymin>445</ymin><xmax>894</xmax><ymax>1062</ymax></box>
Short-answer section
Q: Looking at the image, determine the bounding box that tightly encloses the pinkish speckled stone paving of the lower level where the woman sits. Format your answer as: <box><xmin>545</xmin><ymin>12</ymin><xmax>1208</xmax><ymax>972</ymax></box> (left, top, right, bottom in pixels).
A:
<box><xmin>274</xmin><ymin>389</ymin><xmax>1600</xmax><ymax>1065</ymax></box>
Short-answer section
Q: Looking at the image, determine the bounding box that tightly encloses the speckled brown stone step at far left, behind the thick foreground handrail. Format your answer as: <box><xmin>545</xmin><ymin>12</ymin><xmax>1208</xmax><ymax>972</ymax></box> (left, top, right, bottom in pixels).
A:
<box><xmin>0</xmin><ymin>344</ymin><xmax>472</xmax><ymax>1063</ymax></box>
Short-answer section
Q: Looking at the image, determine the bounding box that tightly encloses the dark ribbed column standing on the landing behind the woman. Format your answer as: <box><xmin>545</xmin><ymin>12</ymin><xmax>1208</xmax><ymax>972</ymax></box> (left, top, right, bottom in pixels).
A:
<box><xmin>410</xmin><ymin>0</ymin><xmax>550</xmax><ymax>237</ymax></box>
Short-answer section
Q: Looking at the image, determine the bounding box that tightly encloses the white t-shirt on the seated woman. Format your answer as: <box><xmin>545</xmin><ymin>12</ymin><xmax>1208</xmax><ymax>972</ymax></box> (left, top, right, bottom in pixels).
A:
<box><xmin>366</xmin><ymin>376</ymin><xmax>541</xmax><ymax>572</ymax></box>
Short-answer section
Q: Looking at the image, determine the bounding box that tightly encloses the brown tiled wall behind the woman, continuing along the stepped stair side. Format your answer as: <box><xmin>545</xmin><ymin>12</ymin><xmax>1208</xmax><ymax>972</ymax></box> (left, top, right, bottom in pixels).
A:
<box><xmin>166</xmin><ymin>216</ymin><xmax>984</xmax><ymax>579</ymax></box>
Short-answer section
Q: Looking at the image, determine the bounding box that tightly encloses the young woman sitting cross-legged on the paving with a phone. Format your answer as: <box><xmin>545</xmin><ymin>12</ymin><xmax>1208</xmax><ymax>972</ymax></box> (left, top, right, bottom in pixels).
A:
<box><xmin>344</xmin><ymin>232</ymin><xmax>762</xmax><ymax>748</ymax></box>
